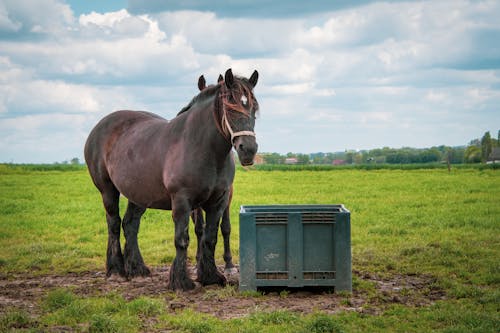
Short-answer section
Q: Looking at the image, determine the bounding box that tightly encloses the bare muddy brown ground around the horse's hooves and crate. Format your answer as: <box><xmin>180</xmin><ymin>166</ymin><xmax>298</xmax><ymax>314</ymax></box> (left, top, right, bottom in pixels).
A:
<box><xmin>0</xmin><ymin>266</ymin><xmax>446</xmax><ymax>319</ymax></box>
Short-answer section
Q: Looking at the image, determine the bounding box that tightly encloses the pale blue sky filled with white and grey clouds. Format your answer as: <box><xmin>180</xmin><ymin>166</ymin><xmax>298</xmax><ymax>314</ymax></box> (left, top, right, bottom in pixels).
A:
<box><xmin>0</xmin><ymin>0</ymin><xmax>500</xmax><ymax>163</ymax></box>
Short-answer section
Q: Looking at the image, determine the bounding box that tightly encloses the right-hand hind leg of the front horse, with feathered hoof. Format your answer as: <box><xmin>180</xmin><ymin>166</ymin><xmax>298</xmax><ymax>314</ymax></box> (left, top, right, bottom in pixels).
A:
<box><xmin>122</xmin><ymin>201</ymin><xmax>151</xmax><ymax>277</ymax></box>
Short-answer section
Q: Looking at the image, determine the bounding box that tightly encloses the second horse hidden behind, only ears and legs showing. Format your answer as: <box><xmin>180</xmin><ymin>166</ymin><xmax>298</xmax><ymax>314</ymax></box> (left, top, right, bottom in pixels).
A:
<box><xmin>189</xmin><ymin>74</ymin><xmax>237</xmax><ymax>274</ymax></box>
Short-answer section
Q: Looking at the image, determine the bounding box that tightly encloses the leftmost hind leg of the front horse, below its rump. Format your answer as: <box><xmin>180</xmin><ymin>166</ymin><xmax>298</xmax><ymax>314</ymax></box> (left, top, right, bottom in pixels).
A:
<box><xmin>101</xmin><ymin>184</ymin><xmax>125</xmax><ymax>277</ymax></box>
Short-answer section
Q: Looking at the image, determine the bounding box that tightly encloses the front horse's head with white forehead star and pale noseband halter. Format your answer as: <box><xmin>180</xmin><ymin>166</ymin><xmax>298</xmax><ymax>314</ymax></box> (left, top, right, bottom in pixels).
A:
<box><xmin>219</xmin><ymin>69</ymin><xmax>259</xmax><ymax>165</ymax></box>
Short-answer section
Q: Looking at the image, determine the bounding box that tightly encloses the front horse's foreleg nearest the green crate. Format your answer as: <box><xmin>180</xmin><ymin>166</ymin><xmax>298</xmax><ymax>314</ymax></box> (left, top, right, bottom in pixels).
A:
<box><xmin>197</xmin><ymin>208</ymin><xmax>227</xmax><ymax>285</ymax></box>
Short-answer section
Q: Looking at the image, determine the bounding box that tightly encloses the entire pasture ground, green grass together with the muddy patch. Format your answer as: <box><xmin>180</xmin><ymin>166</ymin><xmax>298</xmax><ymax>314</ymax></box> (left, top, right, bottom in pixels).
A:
<box><xmin>0</xmin><ymin>165</ymin><xmax>500</xmax><ymax>332</ymax></box>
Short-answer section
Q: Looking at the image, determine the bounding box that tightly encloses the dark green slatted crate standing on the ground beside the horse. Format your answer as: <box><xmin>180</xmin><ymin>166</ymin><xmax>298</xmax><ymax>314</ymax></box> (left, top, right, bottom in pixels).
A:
<box><xmin>239</xmin><ymin>205</ymin><xmax>352</xmax><ymax>291</ymax></box>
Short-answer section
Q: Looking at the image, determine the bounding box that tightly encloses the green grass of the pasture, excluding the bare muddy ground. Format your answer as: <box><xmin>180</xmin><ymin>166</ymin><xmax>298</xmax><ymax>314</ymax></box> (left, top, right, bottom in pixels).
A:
<box><xmin>0</xmin><ymin>165</ymin><xmax>500</xmax><ymax>332</ymax></box>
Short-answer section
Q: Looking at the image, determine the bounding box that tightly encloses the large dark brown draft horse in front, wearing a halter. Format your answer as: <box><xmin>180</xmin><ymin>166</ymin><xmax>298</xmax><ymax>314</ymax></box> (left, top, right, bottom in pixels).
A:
<box><xmin>85</xmin><ymin>69</ymin><xmax>258</xmax><ymax>290</ymax></box>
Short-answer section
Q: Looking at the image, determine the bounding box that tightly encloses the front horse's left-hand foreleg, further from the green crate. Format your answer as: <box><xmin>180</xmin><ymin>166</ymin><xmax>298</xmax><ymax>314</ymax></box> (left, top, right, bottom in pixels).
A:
<box><xmin>169</xmin><ymin>200</ymin><xmax>195</xmax><ymax>290</ymax></box>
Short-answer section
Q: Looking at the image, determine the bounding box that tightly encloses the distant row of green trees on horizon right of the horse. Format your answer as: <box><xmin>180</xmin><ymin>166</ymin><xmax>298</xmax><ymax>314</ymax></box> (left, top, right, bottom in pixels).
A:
<box><xmin>262</xmin><ymin>131</ymin><xmax>500</xmax><ymax>165</ymax></box>
